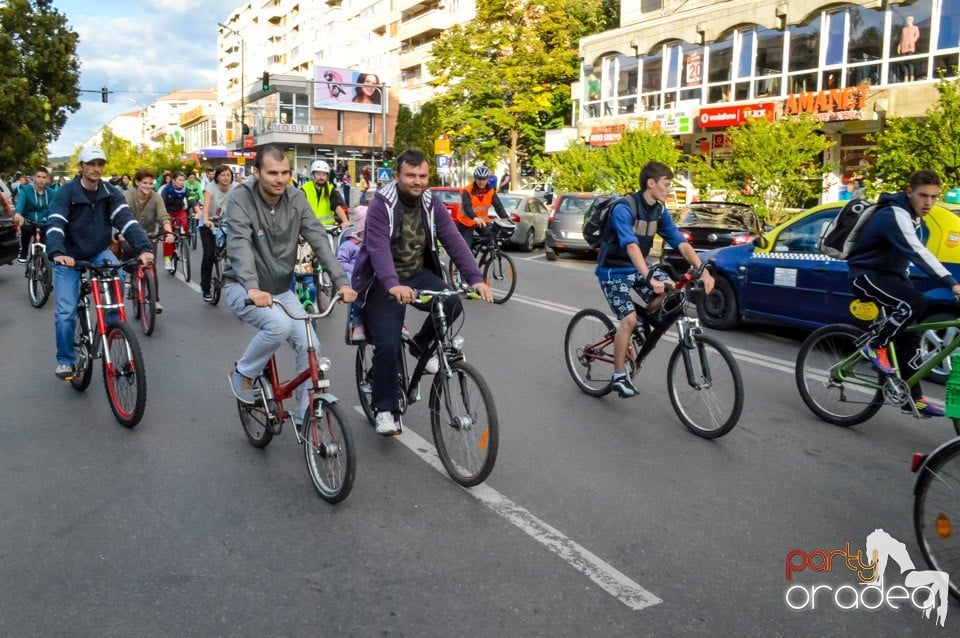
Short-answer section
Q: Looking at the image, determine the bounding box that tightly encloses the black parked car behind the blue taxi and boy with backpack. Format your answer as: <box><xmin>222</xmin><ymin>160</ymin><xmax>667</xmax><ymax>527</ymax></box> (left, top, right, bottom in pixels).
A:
<box><xmin>663</xmin><ymin>202</ymin><xmax>761</xmax><ymax>270</ymax></box>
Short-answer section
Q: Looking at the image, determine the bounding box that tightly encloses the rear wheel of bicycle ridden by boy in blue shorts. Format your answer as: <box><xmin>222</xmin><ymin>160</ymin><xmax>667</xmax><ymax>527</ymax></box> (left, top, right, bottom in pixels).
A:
<box><xmin>563</xmin><ymin>308</ymin><xmax>617</xmax><ymax>397</ymax></box>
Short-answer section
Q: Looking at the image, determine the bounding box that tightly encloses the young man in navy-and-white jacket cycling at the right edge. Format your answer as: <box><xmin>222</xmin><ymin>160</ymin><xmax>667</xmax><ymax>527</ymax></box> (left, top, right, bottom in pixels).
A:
<box><xmin>847</xmin><ymin>170</ymin><xmax>960</xmax><ymax>416</ymax></box>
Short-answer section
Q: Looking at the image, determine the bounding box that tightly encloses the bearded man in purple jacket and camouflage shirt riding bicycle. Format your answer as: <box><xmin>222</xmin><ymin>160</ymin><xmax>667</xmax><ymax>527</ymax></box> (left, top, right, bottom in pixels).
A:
<box><xmin>352</xmin><ymin>148</ymin><xmax>493</xmax><ymax>436</ymax></box>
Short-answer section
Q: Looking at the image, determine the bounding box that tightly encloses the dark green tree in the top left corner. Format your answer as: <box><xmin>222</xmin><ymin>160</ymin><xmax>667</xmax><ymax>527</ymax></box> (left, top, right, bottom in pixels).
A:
<box><xmin>0</xmin><ymin>0</ymin><xmax>80</xmax><ymax>171</ymax></box>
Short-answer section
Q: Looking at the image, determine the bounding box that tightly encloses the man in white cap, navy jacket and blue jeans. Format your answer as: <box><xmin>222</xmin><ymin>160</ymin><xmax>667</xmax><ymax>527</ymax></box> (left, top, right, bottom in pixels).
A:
<box><xmin>47</xmin><ymin>146</ymin><xmax>153</xmax><ymax>379</ymax></box>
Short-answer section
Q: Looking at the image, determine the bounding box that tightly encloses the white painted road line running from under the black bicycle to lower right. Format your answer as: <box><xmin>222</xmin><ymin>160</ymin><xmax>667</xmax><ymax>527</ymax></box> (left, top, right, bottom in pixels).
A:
<box><xmin>354</xmin><ymin>405</ymin><xmax>663</xmax><ymax>611</ymax></box>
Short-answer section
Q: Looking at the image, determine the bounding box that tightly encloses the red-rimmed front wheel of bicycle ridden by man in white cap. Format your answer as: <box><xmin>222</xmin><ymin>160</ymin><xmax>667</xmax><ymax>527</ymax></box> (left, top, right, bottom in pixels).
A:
<box><xmin>103</xmin><ymin>321</ymin><xmax>147</xmax><ymax>428</ymax></box>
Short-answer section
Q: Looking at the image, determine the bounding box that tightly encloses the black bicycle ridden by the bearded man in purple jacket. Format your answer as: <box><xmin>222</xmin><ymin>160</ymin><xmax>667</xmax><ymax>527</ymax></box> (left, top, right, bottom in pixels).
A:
<box><xmin>356</xmin><ymin>289</ymin><xmax>500</xmax><ymax>487</ymax></box>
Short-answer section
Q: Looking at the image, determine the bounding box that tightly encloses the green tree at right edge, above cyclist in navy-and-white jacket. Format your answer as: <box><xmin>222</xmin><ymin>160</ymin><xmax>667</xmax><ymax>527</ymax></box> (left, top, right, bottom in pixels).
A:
<box><xmin>867</xmin><ymin>78</ymin><xmax>960</xmax><ymax>192</ymax></box>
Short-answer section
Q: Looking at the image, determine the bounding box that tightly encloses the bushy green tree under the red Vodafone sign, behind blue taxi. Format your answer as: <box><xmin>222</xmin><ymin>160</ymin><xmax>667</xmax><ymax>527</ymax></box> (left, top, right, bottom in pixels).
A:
<box><xmin>697</xmin><ymin>117</ymin><xmax>833</xmax><ymax>223</ymax></box>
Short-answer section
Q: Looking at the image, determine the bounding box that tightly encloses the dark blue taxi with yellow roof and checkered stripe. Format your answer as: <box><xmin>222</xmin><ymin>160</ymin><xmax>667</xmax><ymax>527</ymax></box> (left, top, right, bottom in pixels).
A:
<box><xmin>696</xmin><ymin>202</ymin><xmax>960</xmax><ymax>382</ymax></box>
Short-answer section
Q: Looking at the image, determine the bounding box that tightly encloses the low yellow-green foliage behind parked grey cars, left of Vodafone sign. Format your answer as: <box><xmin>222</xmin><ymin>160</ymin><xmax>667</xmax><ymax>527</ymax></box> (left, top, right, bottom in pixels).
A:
<box><xmin>540</xmin><ymin>128</ymin><xmax>680</xmax><ymax>193</ymax></box>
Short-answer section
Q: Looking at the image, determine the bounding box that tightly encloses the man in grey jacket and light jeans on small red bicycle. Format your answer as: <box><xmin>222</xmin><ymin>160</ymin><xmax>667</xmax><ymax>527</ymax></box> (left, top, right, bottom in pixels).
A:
<box><xmin>223</xmin><ymin>145</ymin><xmax>357</xmax><ymax>423</ymax></box>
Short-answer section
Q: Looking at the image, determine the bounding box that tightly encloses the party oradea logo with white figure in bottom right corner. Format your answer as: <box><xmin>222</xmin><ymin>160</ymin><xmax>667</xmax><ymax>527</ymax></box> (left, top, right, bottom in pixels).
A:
<box><xmin>784</xmin><ymin>529</ymin><xmax>949</xmax><ymax>627</ymax></box>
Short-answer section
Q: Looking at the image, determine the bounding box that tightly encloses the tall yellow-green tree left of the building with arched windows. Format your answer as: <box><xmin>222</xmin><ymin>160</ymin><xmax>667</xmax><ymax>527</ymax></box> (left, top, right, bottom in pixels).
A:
<box><xmin>427</xmin><ymin>0</ymin><xmax>605</xmax><ymax>183</ymax></box>
